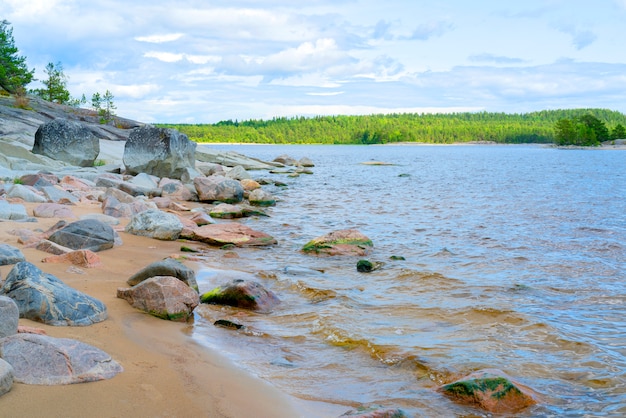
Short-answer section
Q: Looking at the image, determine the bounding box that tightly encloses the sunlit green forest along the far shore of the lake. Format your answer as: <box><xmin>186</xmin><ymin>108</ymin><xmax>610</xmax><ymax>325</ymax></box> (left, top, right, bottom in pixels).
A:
<box><xmin>158</xmin><ymin>109</ymin><xmax>626</xmax><ymax>144</ymax></box>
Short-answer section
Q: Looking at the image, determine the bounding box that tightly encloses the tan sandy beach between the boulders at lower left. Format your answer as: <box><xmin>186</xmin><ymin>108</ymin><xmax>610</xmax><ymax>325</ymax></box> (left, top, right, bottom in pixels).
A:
<box><xmin>0</xmin><ymin>202</ymin><xmax>314</xmax><ymax>418</ymax></box>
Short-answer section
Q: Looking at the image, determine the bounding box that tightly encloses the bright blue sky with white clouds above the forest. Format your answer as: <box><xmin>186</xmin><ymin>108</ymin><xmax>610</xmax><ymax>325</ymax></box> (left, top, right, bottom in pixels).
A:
<box><xmin>0</xmin><ymin>0</ymin><xmax>626</xmax><ymax>123</ymax></box>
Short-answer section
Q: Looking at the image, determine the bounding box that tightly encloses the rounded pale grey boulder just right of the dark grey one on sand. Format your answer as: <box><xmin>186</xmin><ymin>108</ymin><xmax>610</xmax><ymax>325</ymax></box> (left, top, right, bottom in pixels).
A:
<box><xmin>126</xmin><ymin>209</ymin><xmax>183</xmax><ymax>241</ymax></box>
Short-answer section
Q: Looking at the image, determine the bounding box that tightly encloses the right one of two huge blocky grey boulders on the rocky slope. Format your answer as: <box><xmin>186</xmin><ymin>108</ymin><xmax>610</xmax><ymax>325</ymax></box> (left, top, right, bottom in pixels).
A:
<box><xmin>123</xmin><ymin>125</ymin><xmax>196</xmax><ymax>179</ymax></box>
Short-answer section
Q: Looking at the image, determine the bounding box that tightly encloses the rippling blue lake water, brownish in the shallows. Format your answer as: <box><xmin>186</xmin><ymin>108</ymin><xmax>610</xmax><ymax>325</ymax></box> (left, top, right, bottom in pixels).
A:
<box><xmin>192</xmin><ymin>145</ymin><xmax>626</xmax><ymax>417</ymax></box>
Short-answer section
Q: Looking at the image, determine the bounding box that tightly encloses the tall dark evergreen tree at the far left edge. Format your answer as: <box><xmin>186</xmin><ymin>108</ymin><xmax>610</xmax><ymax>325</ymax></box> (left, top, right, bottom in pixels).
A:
<box><xmin>0</xmin><ymin>20</ymin><xmax>35</xmax><ymax>94</ymax></box>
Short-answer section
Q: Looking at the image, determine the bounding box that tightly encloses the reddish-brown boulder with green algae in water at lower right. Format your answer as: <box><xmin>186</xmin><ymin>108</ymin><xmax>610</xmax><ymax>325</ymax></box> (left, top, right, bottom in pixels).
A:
<box><xmin>440</xmin><ymin>369</ymin><xmax>536</xmax><ymax>414</ymax></box>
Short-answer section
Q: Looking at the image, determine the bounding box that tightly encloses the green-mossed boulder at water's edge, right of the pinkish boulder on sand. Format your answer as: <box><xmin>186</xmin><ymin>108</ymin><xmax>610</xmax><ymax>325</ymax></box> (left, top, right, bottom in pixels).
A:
<box><xmin>200</xmin><ymin>279</ymin><xmax>280</xmax><ymax>312</ymax></box>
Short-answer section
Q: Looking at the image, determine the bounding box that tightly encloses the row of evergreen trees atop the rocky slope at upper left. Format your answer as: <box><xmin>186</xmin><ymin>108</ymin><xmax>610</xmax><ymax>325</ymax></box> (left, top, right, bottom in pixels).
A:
<box><xmin>0</xmin><ymin>20</ymin><xmax>116</xmax><ymax>124</ymax></box>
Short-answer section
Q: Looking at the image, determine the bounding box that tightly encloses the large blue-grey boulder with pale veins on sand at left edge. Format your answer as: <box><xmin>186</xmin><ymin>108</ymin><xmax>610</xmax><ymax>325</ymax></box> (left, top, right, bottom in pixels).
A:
<box><xmin>0</xmin><ymin>261</ymin><xmax>107</xmax><ymax>326</ymax></box>
